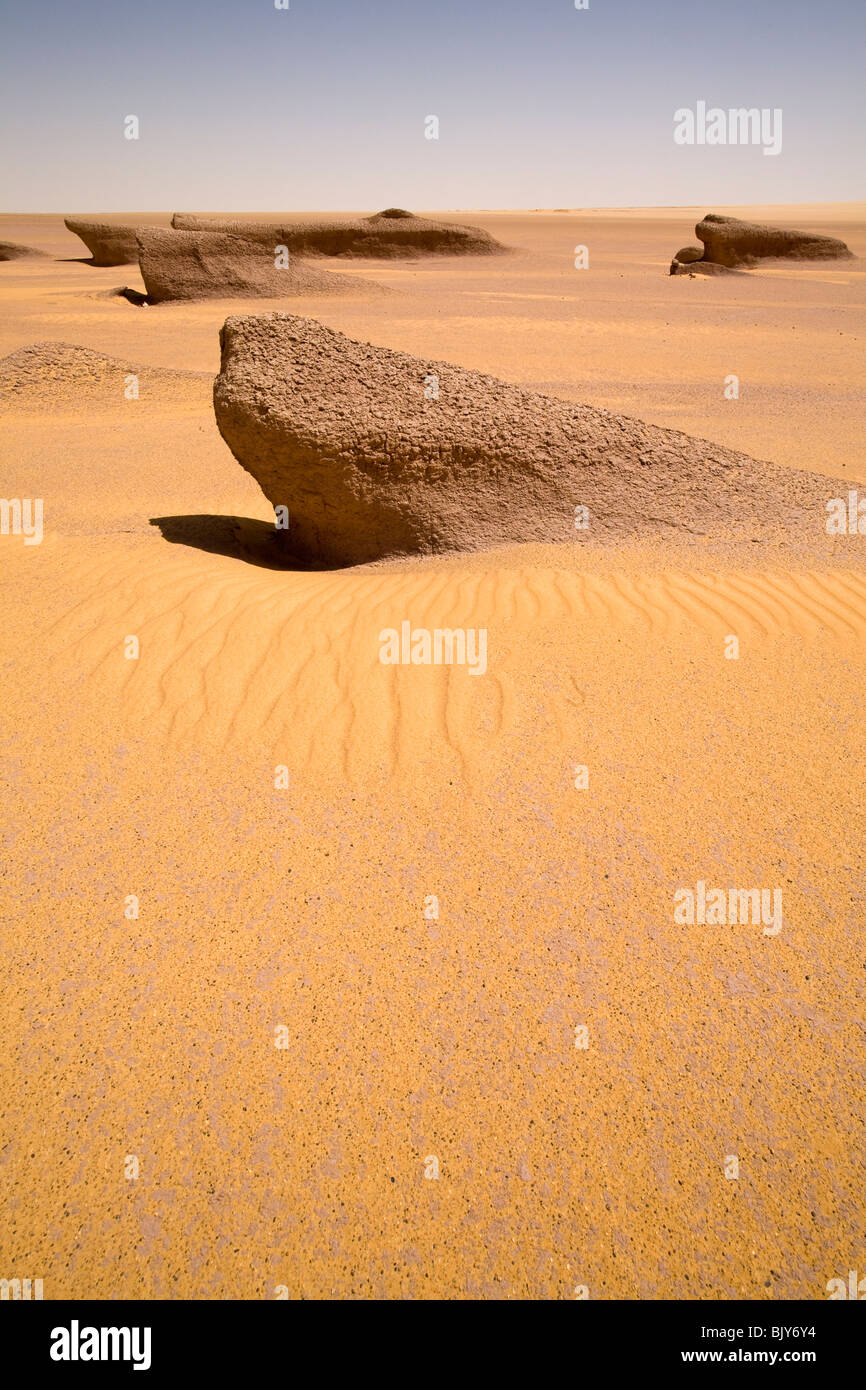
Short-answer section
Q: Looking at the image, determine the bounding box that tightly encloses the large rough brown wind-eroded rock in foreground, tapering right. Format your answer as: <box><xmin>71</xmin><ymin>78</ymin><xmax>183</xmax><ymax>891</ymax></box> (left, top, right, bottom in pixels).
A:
<box><xmin>214</xmin><ymin>314</ymin><xmax>838</xmax><ymax>564</ymax></box>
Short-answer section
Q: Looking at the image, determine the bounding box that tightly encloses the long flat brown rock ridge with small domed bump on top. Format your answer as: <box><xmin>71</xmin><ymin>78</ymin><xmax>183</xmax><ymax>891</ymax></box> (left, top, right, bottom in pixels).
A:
<box><xmin>171</xmin><ymin>207</ymin><xmax>506</xmax><ymax>259</ymax></box>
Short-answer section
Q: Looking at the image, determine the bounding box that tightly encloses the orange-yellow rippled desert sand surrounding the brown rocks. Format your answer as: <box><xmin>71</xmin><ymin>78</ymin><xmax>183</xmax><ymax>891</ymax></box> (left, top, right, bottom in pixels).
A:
<box><xmin>0</xmin><ymin>204</ymin><xmax>866</xmax><ymax>1300</ymax></box>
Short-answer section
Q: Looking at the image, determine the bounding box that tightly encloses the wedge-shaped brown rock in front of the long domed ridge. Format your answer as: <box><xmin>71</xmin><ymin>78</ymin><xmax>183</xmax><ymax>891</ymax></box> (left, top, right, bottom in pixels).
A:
<box><xmin>138</xmin><ymin>228</ymin><xmax>381</xmax><ymax>304</ymax></box>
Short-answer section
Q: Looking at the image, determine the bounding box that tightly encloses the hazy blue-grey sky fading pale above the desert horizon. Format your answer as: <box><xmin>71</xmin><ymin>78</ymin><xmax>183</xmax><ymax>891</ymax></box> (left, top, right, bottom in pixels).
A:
<box><xmin>0</xmin><ymin>0</ymin><xmax>866</xmax><ymax>214</ymax></box>
